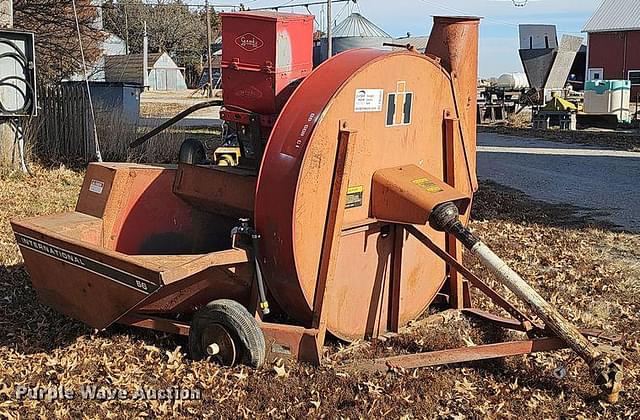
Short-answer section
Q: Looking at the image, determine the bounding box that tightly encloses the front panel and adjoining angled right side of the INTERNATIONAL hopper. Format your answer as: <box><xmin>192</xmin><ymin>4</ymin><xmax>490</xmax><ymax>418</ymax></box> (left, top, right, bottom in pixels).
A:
<box><xmin>13</xmin><ymin>218</ymin><xmax>253</xmax><ymax>329</ymax></box>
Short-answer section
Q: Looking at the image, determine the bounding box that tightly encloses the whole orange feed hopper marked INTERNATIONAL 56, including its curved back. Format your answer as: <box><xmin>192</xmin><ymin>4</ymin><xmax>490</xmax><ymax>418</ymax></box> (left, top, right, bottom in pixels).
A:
<box><xmin>13</xmin><ymin>164</ymin><xmax>255</xmax><ymax>329</ymax></box>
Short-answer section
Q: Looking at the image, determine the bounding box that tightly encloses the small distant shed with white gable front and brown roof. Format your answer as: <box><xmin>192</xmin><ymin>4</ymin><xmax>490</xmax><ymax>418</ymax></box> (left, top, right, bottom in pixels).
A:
<box><xmin>105</xmin><ymin>53</ymin><xmax>187</xmax><ymax>91</ymax></box>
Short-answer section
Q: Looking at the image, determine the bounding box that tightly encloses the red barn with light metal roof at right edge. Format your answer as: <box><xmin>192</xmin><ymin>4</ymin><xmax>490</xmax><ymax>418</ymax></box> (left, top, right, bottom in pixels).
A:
<box><xmin>582</xmin><ymin>0</ymin><xmax>640</xmax><ymax>97</ymax></box>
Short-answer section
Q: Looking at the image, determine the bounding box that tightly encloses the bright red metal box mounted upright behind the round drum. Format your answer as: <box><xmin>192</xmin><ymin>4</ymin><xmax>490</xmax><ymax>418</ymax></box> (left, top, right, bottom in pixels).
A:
<box><xmin>220</xmin><ymin>12</ymin><xmax>313</xmax><ymax>168</ymax></box>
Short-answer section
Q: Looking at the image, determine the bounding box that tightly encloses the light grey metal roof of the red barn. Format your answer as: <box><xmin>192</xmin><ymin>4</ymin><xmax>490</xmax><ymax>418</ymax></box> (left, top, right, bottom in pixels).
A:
<box><xmin>582</xmin><ymin>0</ymin><xmax>640</xmax><ymax>33</ymax></box>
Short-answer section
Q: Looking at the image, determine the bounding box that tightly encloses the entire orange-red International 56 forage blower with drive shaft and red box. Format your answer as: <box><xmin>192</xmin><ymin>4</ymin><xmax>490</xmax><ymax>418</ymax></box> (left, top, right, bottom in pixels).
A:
<box><xmin>12</xmin><ymin>13</ymin><xmax>622</xmax><ymax>400</ymax></box>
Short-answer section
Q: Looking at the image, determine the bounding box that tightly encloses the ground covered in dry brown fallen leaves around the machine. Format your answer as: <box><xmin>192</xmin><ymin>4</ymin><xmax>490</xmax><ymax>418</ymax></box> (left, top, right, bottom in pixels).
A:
<box><xmin>0</xmin><ymin>168</ymin><xmax>640</xmax><ymax>418</ymax></box>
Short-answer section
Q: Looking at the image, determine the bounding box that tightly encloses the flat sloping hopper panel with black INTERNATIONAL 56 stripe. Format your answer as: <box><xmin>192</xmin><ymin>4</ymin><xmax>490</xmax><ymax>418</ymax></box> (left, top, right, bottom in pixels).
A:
<box><xmin>13</xmin><ymin>218</ymin><xmax>159</xmax><ymax>329</ymax></box>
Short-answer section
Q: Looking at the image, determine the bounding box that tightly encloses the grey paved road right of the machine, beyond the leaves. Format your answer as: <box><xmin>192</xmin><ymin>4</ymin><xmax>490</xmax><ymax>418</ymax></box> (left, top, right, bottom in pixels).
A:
<box><xmin>478</xmin><ymin>133</ymin><xmax>640</xmax><ymax>232</ymax></box>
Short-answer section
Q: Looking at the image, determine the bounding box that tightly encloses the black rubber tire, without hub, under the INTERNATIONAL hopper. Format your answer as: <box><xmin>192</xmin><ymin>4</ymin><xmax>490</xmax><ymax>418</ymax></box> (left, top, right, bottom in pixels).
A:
<box><xmin>189</xmin><ymin>299</ymin><xmax>266</xmax><ymax>368</ymax></box>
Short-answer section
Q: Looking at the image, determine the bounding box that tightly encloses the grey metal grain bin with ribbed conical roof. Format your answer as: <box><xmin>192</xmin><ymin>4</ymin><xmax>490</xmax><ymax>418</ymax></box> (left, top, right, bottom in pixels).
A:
<box><xmin>314</xmin><ymin>13</ymin><xmax>394</xmax><ymax>65</ymax></box>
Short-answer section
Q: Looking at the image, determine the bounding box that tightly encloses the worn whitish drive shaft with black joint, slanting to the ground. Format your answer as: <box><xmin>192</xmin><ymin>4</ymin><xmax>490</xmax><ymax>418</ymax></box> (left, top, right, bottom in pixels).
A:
<box><xmin>429</xmin><ymin>202</ymin><xmax>623</xmax><ymax>403</ymax></box>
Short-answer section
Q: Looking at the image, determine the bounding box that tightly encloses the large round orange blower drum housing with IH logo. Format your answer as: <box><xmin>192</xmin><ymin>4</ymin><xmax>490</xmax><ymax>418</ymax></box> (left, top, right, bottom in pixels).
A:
<box><xmin>255</xmin><ymin>44</ymin><xmax>475</xmax><ymax>340</ymax></box>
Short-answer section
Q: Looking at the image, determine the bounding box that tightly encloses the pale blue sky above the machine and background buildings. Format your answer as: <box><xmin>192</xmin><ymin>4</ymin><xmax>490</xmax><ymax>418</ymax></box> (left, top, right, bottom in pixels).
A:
<box><xmin>191</xmin><ymin>0</ymin><xmax>601</xmax><ymax>77</ymax></box>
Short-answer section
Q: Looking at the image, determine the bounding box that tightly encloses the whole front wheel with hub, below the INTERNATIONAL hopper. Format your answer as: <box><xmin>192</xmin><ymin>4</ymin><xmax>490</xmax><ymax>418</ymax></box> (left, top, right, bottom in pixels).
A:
<box><xmin>189</xmin><ymin>299</ymin><xmax>266</xmax><ymax>367</ymax></box>
